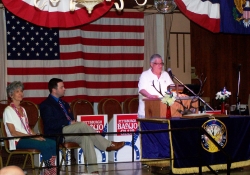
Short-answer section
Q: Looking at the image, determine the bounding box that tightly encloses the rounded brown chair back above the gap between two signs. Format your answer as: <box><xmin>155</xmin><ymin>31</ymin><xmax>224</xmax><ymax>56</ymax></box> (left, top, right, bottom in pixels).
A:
<box><xmin>102</xmin><ymin>98</ymin><xmax>122</xmax><ymax>122</ymax></box>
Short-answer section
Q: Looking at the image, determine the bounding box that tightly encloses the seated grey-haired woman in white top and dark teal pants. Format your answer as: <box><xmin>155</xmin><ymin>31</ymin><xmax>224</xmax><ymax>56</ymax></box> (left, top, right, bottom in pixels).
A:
<box><xmin>3</xmin><ymin>81</ymin><xmax>56</xmax><ymax>175</ymax></box>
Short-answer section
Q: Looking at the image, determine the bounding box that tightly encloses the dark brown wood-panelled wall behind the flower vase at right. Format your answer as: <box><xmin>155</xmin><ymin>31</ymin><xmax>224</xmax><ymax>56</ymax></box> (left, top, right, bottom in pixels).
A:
<box><xmin>191</xmin><ymin>22</ymin><xmax>250</xmax><ymax>107</ymax></box>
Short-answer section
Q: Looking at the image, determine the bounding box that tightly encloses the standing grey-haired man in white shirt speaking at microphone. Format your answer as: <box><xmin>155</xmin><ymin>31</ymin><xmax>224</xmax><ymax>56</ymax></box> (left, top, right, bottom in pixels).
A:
<box><xmin>138</xmin><ymin>54</ymin><xmax>174</xmax><ymax>118</ymax></box>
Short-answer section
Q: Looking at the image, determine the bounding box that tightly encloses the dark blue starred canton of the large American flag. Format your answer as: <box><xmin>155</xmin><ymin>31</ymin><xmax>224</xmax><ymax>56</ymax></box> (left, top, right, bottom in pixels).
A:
<box><xmin>6</xmin><ymin>11</ymin><xmax>60</xmax><ymax>60</ymax></box>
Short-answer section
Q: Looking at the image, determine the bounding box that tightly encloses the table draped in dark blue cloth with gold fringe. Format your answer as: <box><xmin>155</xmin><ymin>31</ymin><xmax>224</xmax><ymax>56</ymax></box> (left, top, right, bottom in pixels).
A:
<box><xmin>138</xmin><ymin>116</ymin><xmax>250</xmax><ymax>174</ymax></box>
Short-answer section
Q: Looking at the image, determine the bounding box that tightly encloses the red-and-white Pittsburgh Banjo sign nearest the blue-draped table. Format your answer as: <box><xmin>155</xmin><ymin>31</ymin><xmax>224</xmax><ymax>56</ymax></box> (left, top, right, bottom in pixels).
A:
<box><xmin>108</xmin><ymin>114</ymin><xmax>141</xmax><ymax>162</ymax></box>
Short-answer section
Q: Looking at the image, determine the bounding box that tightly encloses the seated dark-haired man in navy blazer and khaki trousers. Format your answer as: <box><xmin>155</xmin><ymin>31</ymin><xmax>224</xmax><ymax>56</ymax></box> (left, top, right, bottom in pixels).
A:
<box><xmin>40</xmin><ymin>78</ymin><xmax>124</xmax><ymax>174</ymax></box>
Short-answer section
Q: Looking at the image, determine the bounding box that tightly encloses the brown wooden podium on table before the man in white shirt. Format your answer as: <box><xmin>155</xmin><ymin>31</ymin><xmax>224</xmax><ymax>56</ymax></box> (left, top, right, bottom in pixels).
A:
<box><xmin>143</xmin><ymin>96</ymin><xmax>199</xmax><ymax>118</ymax></box>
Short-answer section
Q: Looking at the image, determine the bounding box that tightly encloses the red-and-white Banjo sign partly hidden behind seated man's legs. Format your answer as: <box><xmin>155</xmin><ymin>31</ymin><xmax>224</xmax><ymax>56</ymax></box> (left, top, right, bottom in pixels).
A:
<box><xmin>75</xmin><ymin>114</ymin><xmax>108</xmax><ymax>164</ymax></box>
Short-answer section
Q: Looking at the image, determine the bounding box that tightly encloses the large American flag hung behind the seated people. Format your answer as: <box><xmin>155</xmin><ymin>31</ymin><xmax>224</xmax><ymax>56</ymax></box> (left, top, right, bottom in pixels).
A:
<box><xmin>6</xmin><ymin>11</ymin><xmax>144</xmax><ymax>104</ymax></box>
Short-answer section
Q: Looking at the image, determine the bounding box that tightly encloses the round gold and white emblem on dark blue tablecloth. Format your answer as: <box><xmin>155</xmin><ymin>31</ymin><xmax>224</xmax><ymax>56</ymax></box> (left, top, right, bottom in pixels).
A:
<box><xmin>201</xmin><ymin>119</ymin><xmax>227</xmax><ymax>153</ymax></box>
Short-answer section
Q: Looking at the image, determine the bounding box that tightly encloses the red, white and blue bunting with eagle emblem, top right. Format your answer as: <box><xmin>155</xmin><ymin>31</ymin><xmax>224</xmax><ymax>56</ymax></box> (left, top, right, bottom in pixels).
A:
<box><xmin>175</xmin><ymin>0</ymin><xmax>250</xmax><ymax>34</ymax></box>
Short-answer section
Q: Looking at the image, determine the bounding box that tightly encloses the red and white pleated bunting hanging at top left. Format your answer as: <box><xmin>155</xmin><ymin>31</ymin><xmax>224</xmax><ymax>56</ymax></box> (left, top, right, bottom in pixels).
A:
<box><xmin>2</xmin><ymin>0</ymin><xmax>114</xmax><ymax>28</ymax></box>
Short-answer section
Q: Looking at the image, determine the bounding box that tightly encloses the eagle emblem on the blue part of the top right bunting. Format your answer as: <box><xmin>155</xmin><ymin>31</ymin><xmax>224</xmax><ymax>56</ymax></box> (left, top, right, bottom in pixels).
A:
<box><xmin>233</xmin><ymin>0</ymin><xmax>250</xmax><ymax>28</ymax></box>
